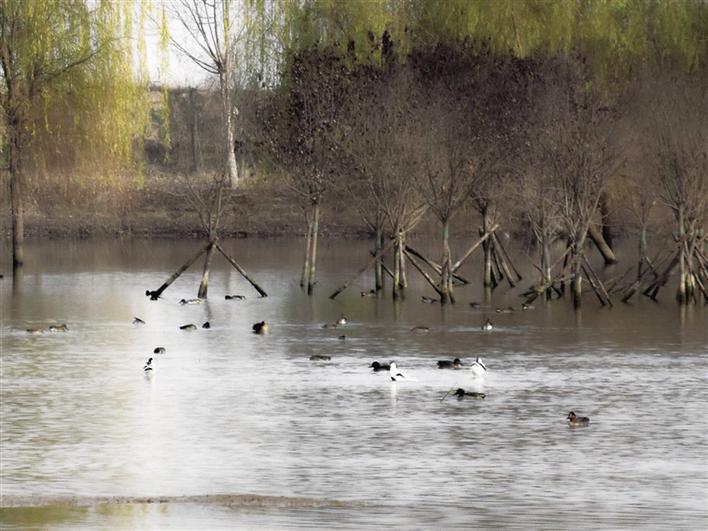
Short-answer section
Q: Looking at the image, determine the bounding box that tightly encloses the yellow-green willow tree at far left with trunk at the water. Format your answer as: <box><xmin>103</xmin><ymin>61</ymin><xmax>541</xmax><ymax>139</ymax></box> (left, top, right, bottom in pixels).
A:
<box><xmin>0</xmin><ymin>0</ymin><xmax>153</xmax><ymax>267</ymax></box>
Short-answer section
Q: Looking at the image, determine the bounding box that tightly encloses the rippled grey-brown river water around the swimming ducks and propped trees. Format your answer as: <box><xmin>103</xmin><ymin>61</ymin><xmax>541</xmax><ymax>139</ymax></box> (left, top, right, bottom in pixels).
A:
<box><xmin>0</xmin><ymin>240</ymin><xmax>708</xmax><ymax>529</ymax></box>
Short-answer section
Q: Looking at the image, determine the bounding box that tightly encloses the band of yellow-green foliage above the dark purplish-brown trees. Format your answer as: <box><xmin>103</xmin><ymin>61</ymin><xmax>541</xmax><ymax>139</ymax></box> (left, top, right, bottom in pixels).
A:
<box><xmin>276</xmin><ymin>0</ymin><xmax>708</xmax><ymax>80</ymax></box>
